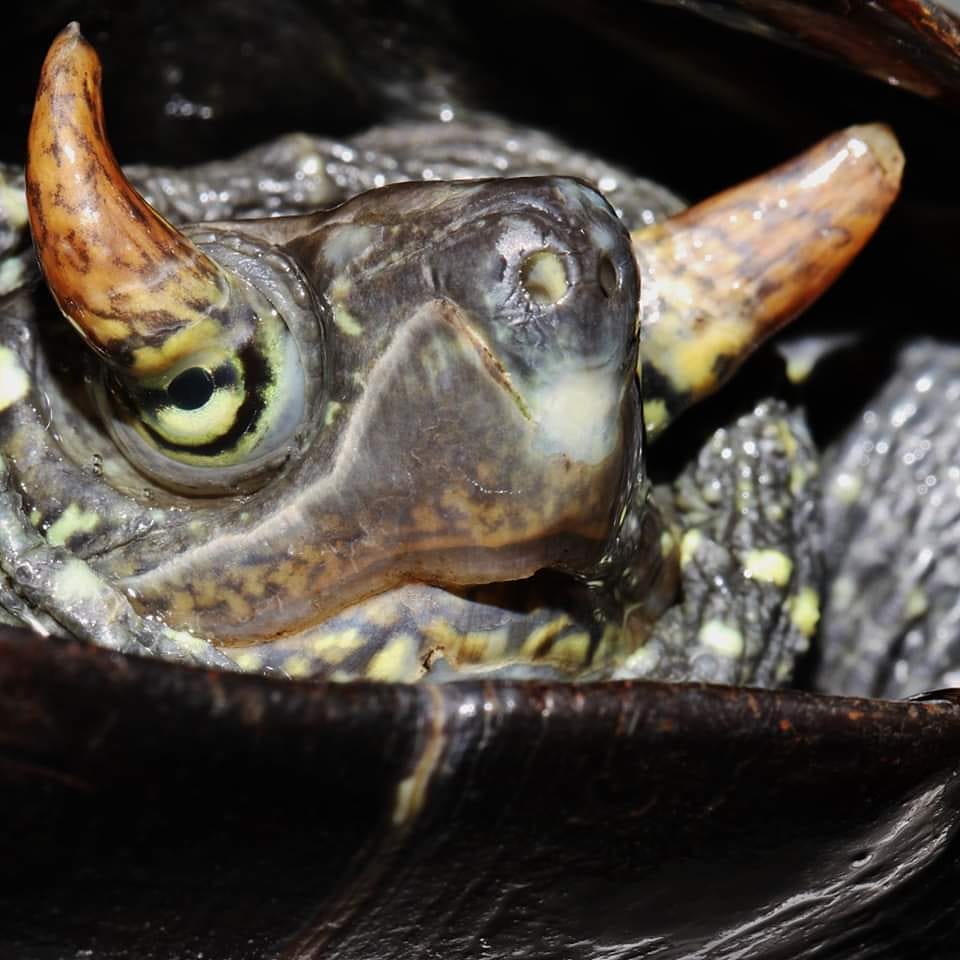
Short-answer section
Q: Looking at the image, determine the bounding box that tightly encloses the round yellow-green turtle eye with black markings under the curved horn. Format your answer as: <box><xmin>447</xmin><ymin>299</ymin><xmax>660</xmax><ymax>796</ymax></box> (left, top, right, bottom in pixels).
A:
<box><xmin>95</xmin><ymin>298</ymin><xmax>305</xmax><ymax>494</ymax></box>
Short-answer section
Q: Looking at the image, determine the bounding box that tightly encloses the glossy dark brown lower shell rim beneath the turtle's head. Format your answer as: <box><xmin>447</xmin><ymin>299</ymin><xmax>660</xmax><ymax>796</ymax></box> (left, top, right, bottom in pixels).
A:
<box><xmin>0</xmin><ymin>631</ymin><xmax>960</xmax><ymax>960</ymax></box>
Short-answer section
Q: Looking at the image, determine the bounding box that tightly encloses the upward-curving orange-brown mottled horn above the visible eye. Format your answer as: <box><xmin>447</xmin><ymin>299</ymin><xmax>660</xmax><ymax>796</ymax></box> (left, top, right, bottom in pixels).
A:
<box><xmin>26</xmin><ymin>23</ymin><xmax>230</xmax><ymax>376</ymax></box>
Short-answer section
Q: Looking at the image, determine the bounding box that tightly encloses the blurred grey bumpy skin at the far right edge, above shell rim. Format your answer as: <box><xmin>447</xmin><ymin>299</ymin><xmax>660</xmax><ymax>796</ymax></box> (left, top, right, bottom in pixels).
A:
<box><xmin>816</xmin><ymin>339</ymin><xmax>960</xmax><ymax>697</ymax></box>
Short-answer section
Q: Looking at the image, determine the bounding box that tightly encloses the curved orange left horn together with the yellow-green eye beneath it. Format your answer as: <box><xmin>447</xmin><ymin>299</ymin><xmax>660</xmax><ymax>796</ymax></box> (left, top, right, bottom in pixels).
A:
<box><xmin>26</xmin><ymin>24</ymin><xmax>306</xmax><ymax>494</ymax></box>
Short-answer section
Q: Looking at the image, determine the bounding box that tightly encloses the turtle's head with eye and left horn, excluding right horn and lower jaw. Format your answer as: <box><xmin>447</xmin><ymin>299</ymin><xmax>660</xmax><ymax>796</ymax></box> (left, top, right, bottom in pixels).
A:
<box><xmin>27</xmin><ymin>25</ymin><xmax>642</xmax><ymax>638</ymax></box>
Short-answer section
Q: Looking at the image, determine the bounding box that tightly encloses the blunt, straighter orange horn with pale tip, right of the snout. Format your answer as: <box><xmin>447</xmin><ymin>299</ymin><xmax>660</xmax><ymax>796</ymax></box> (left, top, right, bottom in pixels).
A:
<box><xmin>631</xmin><ymin>124</ymin><xmax>904</xmax><ymax>436</ymax></box>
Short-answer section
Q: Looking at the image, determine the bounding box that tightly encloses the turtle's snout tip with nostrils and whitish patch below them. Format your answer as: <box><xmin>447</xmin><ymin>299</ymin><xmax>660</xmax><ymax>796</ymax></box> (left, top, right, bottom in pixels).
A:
<box><xmin>495</xmin><ymin>178</ymin><xmax>639</xmax><ymax>464</ymax></box>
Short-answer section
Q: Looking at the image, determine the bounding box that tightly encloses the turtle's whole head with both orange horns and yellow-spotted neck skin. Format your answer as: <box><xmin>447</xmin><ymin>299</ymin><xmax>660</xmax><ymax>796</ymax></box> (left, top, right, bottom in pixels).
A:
<box><xmin>3</xmin><ymin>25</ymin><xmax>903</xmax><ymax>684</ymax></box>
